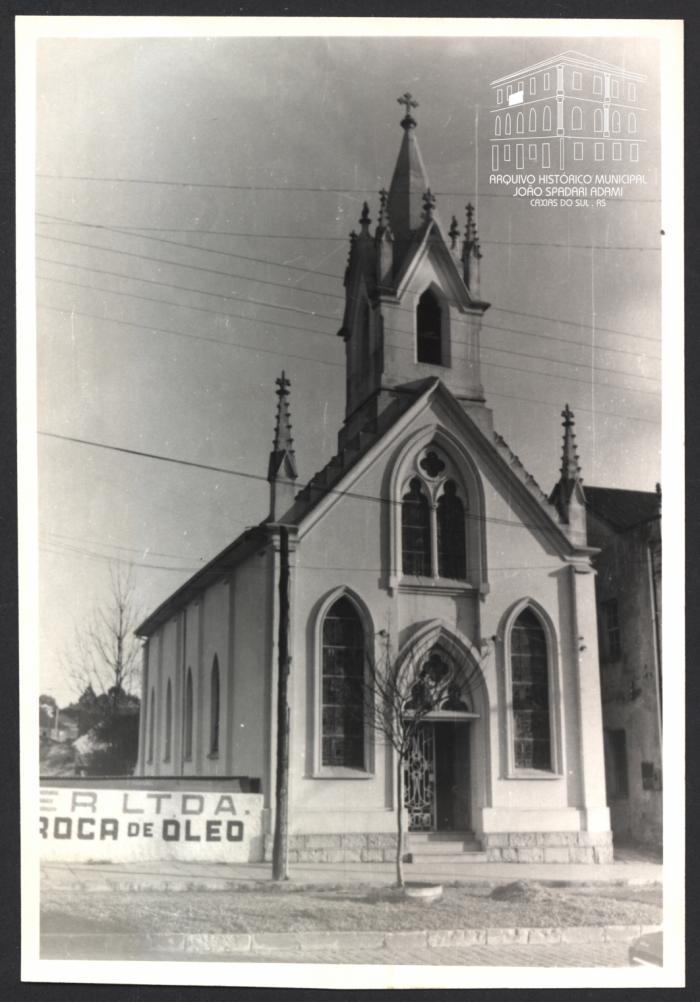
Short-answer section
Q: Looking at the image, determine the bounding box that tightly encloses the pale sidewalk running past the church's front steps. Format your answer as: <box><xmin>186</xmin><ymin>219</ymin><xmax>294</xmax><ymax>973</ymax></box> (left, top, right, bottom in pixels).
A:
<box><xmin>41</xmin><ymin>856</ymin><xmax>663</xmax><ymax>891</ymax></box>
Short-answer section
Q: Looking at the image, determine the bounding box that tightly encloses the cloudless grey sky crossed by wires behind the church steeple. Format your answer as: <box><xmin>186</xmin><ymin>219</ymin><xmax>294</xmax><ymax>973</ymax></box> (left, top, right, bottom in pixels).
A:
<box><xmin>36</xmin><ymin>31</ymin><xmax>662</xmax><ymax>704</ymax></box>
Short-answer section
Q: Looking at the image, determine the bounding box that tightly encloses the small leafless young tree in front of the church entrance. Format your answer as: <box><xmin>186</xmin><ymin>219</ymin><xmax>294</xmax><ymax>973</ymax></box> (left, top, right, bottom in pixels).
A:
<box><xmin>362</xmin><ymin>630</ymin><xmax>484</xmax><ymax>887</ymax></box>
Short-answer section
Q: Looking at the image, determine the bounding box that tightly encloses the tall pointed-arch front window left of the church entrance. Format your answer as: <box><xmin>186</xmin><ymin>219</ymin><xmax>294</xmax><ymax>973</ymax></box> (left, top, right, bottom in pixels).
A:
<box><xmin>321</xmin><ymin>596</ymin><xmax>365</xmax><ymax>769</ymax></box>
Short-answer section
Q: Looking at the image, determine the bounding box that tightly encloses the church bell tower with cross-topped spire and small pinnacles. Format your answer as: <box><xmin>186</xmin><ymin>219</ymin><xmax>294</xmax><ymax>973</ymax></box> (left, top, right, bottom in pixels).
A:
<box><xmin>338</xmin><ymin>93</ymin><xmax>490</xmax><ymax>446</ymax></box>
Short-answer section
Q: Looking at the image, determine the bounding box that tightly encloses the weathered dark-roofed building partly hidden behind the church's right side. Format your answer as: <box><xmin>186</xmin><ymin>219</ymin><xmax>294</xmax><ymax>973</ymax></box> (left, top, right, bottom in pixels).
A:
<box><xmin>586</xmin><ymin>487</ymin><xmax>662</xmax><ymax>845</ymax></box>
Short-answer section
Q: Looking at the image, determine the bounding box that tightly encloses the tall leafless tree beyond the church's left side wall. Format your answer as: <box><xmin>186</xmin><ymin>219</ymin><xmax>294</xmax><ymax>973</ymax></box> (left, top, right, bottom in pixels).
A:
<box><xmin>61</xmin><ymin>564</ymin><xmax>141</xmax><ymax>703</ymax></box>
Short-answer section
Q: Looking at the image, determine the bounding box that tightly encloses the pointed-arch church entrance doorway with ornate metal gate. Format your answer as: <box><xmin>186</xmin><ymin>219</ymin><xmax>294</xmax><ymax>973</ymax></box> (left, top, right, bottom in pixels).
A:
<box><xmin>404</xmin><ymin>644</ymin><xmax>479</xmax><ymax>833</ymax></box>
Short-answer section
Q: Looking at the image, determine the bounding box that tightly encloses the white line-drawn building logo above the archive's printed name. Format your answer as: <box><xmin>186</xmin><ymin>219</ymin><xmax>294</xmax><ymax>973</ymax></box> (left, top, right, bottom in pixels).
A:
<box><xmin>490</xmin><ymin>50</ymin><xmax>646</xmax><ymax>173</ymax></box>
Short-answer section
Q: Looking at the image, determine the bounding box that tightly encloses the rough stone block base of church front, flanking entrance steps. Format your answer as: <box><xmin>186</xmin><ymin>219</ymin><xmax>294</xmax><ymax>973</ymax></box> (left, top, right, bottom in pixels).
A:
<box><xmin>264</xmin><ymin>832</ymin><xmax>613</xmax><ymax>863</ymax></box>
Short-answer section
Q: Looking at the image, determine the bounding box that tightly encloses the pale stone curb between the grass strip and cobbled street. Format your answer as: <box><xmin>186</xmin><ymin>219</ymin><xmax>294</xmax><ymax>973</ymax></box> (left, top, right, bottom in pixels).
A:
<box><xmin>41</xmin><ymin>925</ymin><xmax>662</xmax><ymax>960</ymax></box>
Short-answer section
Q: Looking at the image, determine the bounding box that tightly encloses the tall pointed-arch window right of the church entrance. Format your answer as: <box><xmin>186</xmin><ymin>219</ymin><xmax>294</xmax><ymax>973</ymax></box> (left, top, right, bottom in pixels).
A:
<box><xmin>511</xmin><ymin>608</ymin><xmax>552</xmax><ymax>770</ymax></box>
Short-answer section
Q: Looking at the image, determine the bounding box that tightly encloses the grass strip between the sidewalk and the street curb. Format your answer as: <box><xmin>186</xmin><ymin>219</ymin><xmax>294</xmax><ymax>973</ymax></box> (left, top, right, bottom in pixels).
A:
<box><xmin>41</xmin><ymin>883</ymin><xmax>661</xmax><ymax>933</ymax></box>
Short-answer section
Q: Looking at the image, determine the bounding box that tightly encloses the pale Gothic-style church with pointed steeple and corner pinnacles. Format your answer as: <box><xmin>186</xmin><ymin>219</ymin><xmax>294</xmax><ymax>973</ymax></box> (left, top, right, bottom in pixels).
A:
<box><xmin>136</xmin><ymin>94</ymin><xmax>612</xmax><ymax>863</ymax></box>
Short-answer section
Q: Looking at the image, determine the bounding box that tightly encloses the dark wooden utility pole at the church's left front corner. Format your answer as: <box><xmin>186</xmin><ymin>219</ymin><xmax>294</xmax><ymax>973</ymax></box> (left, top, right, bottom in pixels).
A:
<box><xmin>272</xmin><ymin>525</ymin><xmax>291</xmax><ymax>880</ymax></box>
